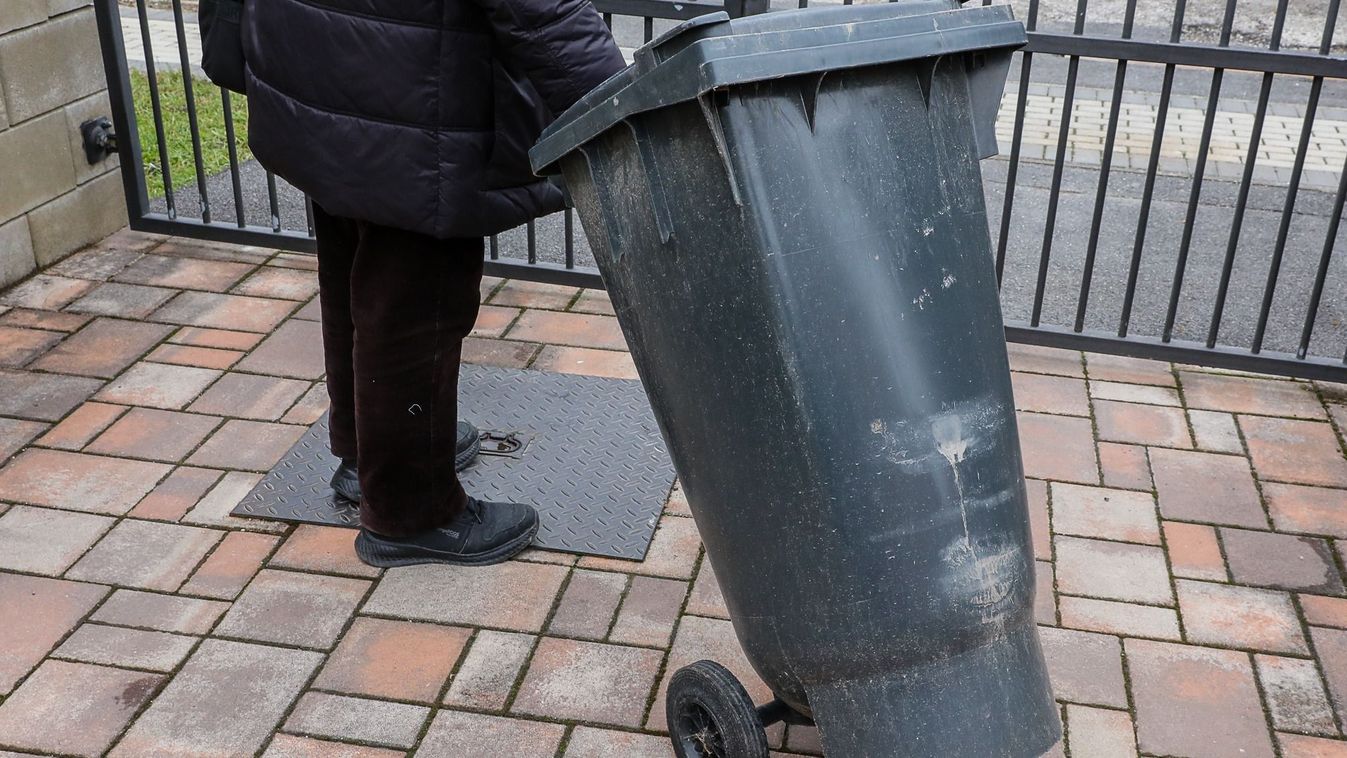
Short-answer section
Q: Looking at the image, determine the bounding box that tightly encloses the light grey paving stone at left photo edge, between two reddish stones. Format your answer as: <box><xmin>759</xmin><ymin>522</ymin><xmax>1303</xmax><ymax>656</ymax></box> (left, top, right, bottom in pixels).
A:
<box><xmin>0</xmin><ymin>505</ymin><xmax>113</xmax><ymax>576</ymax></box>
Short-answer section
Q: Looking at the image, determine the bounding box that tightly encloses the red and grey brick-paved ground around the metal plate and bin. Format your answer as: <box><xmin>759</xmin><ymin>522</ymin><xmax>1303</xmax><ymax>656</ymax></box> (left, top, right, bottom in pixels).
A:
<box><xmin>0</xmin><ymin>233</ymin><xmax>1347</xmax><ymax>758</ymax></box>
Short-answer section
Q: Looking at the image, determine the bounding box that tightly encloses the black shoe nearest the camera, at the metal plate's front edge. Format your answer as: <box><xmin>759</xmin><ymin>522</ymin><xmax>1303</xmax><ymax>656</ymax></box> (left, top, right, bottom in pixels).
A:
<box><xmin>356</xmin><ymin>498</ymin><xmax>537</xmax><ymax>568</ymax></box>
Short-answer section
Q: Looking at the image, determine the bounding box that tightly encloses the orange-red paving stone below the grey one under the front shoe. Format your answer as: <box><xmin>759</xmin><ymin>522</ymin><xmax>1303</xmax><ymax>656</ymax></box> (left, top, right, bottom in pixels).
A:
<box><xmin>314</xmin><ymin>617</ymin><xmax>471</xmax><ymax>705</ymax></box>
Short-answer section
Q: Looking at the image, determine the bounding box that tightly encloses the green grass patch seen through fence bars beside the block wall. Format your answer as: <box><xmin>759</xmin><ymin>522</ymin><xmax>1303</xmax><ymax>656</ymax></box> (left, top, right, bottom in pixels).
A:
<box><xmin>131</xmin><ymin>70</ymin><xmax>252</xmax><ymax>197</ymax></box>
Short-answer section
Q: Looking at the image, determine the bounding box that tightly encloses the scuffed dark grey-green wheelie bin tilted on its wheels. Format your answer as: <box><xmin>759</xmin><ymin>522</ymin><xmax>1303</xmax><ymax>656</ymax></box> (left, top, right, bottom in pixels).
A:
<box><xmin>532</xmin><ymin>0</ymin><xmax>1060</xmax><ymax>758</ymax></box>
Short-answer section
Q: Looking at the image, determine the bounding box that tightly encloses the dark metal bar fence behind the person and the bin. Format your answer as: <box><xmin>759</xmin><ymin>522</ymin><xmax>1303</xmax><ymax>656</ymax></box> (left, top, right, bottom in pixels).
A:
<box><xmin>97</xmin><ymin>0</ymin><xmax>1347</xmax><ymax>381</ymax></box>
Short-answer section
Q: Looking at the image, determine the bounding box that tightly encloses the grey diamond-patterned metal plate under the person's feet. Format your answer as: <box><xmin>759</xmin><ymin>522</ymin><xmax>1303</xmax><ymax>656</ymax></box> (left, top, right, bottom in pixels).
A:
<box><xmin>233</xmin><ymin>365</ymin><xmax>674</xmax><ymax>560</ymax></box>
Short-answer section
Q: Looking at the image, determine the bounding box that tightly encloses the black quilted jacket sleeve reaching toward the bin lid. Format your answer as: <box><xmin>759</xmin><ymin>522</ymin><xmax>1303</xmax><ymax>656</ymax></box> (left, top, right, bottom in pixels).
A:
<box><xmin>473</xmin><ymin>0</ymin><xmax>626</xmax><ymax>114</ymax></box>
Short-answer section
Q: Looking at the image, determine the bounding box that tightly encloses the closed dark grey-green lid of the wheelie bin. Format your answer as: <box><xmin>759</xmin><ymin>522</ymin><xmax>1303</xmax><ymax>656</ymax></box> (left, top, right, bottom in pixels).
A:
<box><xmin>529</xmin><ymin>0</ymin><xmax>1025</xmax><ymax>175</ymax></box>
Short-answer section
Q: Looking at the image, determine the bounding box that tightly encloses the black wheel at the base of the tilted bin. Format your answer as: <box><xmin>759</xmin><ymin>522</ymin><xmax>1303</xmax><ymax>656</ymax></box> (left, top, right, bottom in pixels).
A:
<box><xmin>664</xmin><ymin>661</ymin><xmax>768</xmax><ymax>758</ymax></box>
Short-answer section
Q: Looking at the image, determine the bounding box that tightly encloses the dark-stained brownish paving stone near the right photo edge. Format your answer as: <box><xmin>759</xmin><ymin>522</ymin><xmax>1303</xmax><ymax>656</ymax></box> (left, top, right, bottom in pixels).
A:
<box><xmin>1220</xmin><ymin>529</ymin><xmax>1343</xmax><ymax>595</ymax></box>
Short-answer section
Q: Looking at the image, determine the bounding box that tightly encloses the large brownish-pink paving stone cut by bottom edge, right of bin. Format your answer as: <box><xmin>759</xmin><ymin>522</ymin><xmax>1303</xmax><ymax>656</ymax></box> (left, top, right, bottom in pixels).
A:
<box><xmin>1125</xmin><ymin>640</ymin><xmax>1273</xmax><ymax>758</ymax></box>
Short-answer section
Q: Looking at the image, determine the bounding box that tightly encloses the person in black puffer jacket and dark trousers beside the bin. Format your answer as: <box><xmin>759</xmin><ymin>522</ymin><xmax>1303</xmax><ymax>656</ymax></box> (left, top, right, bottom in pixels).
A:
<box><xmin>242</xmin><ymin>0</ymin><xmax>625</xmax><ymax>567</ymax></box>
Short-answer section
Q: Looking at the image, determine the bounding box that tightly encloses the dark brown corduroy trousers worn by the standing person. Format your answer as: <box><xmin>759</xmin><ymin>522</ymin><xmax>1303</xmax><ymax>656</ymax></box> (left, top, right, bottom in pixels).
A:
<box><xmin>314</xmin><ymin>205</ymin><xmax>482</xmax><ymax>537</ymax></box>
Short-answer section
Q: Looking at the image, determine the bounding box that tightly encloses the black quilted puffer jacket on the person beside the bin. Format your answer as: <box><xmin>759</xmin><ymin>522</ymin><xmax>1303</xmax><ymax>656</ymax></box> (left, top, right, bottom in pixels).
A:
<box><xmin>244</xmin><ymin>0</ymin><xmax>624</xmax><ymax>237</ymax></box>
